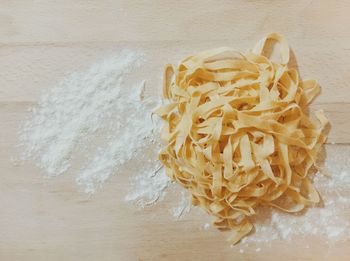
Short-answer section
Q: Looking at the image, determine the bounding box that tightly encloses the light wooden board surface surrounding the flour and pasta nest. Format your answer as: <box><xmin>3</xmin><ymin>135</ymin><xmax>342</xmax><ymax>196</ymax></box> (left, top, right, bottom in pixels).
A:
<box><xmin>0</xmin><ymin>0</ymin><xmax>350</xmax><ymax>261</ymax></box>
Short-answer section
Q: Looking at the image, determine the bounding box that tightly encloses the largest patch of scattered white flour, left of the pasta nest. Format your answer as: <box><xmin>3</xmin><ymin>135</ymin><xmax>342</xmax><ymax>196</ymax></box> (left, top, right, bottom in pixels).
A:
<box><xmin>20</xmin><ymin>50</ymin><xmax>157</xmax><ymax>193</ymax></box>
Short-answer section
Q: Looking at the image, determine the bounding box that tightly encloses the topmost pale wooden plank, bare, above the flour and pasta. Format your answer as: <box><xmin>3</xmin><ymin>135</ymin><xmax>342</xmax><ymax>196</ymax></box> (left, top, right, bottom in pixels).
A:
<box><xmin>0</xmin><ymin>0</ymin><xmax>350</xmax><ymax>44</ymax></box>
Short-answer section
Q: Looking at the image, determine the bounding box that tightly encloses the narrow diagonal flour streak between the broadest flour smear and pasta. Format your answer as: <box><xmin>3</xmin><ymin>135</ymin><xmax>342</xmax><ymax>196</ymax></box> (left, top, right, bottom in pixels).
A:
<box><xmin>77</xmin><ymin>82</ymin><xmax>158</xmax><ymax>192</ymax></box>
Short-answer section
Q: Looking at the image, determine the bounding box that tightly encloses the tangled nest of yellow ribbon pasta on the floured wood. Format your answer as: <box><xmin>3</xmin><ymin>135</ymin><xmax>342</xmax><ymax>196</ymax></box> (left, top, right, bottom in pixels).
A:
<box><xmin>156</xmin><ymin>34</ymin><xmax>327</xmax><ymax>244</ymax></box>
